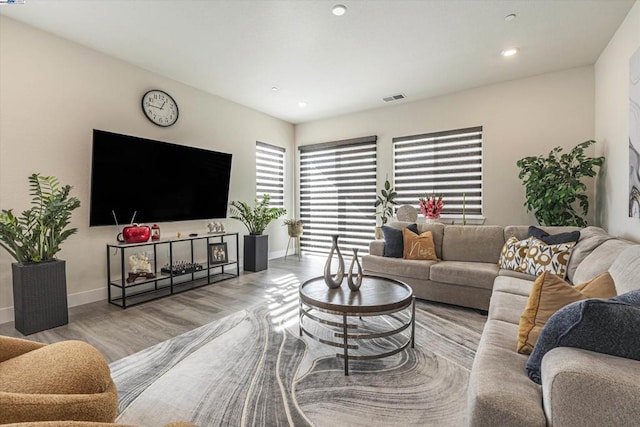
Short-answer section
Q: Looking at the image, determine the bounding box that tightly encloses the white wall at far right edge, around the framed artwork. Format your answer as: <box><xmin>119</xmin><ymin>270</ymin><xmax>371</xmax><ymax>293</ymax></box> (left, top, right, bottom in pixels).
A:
<box><xmin>595</xmin><ymin>2</ymin><xmax>640</xmax><ymax>240</ymax></box>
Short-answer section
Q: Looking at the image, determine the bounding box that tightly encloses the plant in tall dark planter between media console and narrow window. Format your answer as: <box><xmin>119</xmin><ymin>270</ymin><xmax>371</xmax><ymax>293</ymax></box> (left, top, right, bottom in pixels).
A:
<box><xmin>231</xmin><ymin>194</ymin><xmax>287</xmax><ymax>271</ymax></box>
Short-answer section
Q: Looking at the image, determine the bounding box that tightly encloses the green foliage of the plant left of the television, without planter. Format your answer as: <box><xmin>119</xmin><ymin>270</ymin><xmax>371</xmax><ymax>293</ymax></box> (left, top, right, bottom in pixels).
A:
<box><xmin>0</xmin><ymin>173</ymin><xmax>80</xmax><ymax>263</ymax></box>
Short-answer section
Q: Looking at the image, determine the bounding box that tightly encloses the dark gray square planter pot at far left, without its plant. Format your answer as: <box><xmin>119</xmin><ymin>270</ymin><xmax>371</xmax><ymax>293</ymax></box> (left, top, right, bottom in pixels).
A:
<box><xmin>11</xmin><ymin>260</ymin><xmax>69</xmax><ymax>335</ymax></box>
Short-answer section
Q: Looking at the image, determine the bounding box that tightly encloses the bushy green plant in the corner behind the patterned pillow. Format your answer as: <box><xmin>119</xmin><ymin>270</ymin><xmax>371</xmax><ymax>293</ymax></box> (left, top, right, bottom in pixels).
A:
<box><xmin>516</xmin><ymin>140</ymin><xmax>604</xmax><ymax>227</ymax></box>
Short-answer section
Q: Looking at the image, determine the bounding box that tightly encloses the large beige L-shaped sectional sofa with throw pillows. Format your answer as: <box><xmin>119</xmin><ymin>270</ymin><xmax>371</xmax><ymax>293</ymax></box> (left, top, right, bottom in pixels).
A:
<box><xmin>363</xmin><ymin>223</ymin><xmax>640</xmax><ymax>427</ymax></box>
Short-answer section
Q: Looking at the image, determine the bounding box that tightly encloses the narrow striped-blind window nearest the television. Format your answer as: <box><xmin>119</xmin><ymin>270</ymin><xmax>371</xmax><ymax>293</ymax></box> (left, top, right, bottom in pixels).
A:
<box><xmin>256</xmin><ymin>142</ymin><xmax>285</xmax><ymax>208</ymax></box>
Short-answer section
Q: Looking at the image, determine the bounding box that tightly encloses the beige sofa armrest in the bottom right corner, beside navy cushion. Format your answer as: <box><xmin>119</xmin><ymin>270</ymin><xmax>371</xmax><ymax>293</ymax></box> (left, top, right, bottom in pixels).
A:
<box><xmin>542</xmin><ymin>347</ymin><xmax>640</xmax><ymax>426</ymax></box>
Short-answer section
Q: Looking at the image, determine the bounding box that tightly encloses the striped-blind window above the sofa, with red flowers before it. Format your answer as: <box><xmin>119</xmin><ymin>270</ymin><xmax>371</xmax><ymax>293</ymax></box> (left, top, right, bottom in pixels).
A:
<box><xmin>393</xmin><ymin>126</ymin><xmax>482</xmax><ymax>219</ymax></box>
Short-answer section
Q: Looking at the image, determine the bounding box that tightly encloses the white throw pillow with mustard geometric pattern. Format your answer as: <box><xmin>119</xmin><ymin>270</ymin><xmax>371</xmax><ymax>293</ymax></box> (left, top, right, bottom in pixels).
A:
<box><xmin>519</xmin><ymin>237</ymin><xmax>575</xmax><ymax>279</ymax></box>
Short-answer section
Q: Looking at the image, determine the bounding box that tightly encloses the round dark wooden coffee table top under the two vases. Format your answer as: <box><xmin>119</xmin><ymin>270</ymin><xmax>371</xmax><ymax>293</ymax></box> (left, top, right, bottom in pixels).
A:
<box><xmin>300</xmin><ymin>275</ymin><xmax>413</xmax><ymax>314</ymax></box>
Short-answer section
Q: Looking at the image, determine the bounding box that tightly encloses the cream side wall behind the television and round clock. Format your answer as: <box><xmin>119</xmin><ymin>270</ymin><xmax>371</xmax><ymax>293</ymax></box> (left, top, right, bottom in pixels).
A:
<box><xmin>0</xmin><ymin>16</ymin><xmax>294</xmax><ymax>323</ymax></box>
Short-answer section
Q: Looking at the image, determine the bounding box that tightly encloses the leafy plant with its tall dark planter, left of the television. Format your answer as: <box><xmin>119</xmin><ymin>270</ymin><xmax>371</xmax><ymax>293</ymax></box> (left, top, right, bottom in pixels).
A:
<box><xmin>0</xmin><ymin>173</ymin><xmax>80</xmax><ymax>335</ymax></box>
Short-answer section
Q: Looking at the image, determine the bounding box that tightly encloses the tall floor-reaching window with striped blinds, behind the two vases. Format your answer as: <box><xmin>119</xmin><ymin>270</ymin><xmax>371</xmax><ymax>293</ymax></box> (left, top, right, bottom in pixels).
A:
<box><xmin>300</xmin><ymin>136</ymin><xmax>377</xmax><ymax>255</ymax></box>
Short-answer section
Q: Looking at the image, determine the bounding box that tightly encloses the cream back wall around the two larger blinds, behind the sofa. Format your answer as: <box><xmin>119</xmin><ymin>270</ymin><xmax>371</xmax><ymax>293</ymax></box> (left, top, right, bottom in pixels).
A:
<box><xmin>296</xmin><ymin>66</ymin><xmax>594</xmax><ymax>225</ymax></box>
